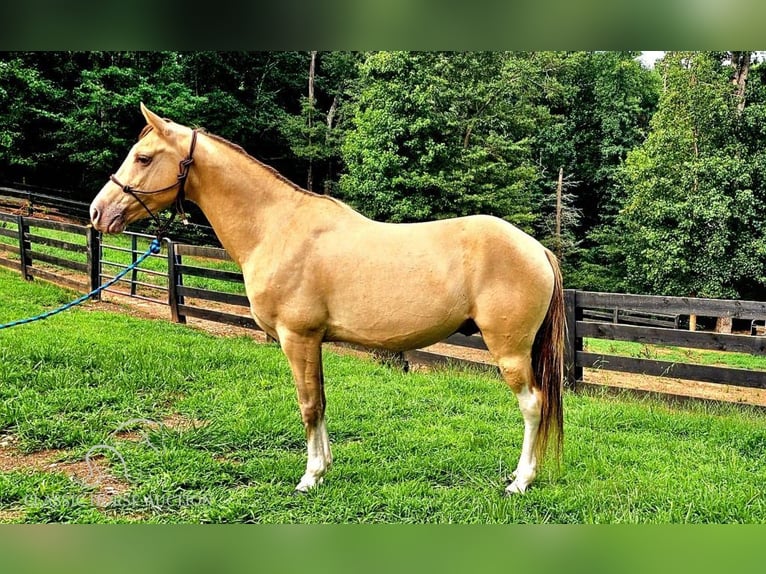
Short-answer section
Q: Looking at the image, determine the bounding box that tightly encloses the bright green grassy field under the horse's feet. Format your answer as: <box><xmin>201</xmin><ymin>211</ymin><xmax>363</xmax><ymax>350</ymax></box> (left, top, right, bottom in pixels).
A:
<box><xmin>0</xmin><ymin>269</ymin><xmax>766</xmax><ymax>523</ymax></box>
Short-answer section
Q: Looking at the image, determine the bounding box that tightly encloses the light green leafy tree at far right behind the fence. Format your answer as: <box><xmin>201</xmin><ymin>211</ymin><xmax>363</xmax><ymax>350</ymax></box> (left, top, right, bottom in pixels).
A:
<box><xmin>620</xmin><ymin>52</ymin><xmax>766</xmax><ymax>297</ymax></box>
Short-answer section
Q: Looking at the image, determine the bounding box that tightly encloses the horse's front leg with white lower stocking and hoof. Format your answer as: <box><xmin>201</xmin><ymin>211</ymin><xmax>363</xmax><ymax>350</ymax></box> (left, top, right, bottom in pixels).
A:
<box><xmin>279</xmin><ymin>333</ymin><xmax>332</xmax><ymax>492</ymax></box>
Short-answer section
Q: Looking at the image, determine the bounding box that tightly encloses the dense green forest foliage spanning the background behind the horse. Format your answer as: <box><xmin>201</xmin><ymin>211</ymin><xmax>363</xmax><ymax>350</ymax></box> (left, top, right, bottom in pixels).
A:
<box><xmin>0</xmin><ymin>52</ymin><xmax>766</xmax><ymax>298</ymax></box>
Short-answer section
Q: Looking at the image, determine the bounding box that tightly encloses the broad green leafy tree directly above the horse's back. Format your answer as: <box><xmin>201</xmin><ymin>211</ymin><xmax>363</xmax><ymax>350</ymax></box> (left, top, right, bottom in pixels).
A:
<box><xmin>340</xmin><ymin>52</ymin><xmax>552</xmax><ymax>231</ymax></box>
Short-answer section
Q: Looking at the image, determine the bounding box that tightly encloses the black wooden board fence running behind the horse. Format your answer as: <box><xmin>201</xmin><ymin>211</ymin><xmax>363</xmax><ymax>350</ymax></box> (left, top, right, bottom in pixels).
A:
<box><xmin>0</xmin><ymin>213</ymin><xmax>766</xmax><ymax>398</ymax></box>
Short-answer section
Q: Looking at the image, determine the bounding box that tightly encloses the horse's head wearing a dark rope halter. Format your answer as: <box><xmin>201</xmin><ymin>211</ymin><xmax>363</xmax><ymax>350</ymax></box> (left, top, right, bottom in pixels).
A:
<box><xmin>90</xmin><ymin>104</ymin><xmax>196</xmax><ymax>233</ymax></box>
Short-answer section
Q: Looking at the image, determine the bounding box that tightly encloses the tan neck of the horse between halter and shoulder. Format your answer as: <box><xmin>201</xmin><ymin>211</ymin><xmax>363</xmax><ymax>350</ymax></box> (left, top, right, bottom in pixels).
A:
<box><xmin>187</xmin><ymin>143</ymin><xmax>324</xmax><ymax>266</ymax></box>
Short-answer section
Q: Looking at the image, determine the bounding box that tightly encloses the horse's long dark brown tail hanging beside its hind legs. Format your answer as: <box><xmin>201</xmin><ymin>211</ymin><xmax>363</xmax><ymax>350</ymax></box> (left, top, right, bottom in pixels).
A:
<box><xmin>532</xmin><ymin>249</ymin><xmax>566</xmax><ymax>466</ymax></box>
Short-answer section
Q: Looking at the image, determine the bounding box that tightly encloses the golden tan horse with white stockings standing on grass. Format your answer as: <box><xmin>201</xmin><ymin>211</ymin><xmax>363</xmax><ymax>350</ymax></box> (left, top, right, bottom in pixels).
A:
<box><xmin>90</xmin><ymin>103</ymin><xmax>566</xmax><ymax>494</ymax></box>
